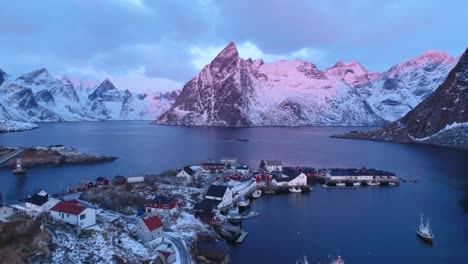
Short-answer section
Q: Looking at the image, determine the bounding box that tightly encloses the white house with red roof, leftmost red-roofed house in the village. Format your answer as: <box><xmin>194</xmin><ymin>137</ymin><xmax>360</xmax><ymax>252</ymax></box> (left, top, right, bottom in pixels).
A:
<box><xmin>50</xmin><ymin>200</ymin><xmax>96</xmax><ymax>228</ymax></box>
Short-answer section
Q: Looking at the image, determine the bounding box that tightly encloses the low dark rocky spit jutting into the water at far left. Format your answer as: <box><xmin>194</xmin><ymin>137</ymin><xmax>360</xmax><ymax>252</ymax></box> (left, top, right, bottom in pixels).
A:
<box><xmin>0</xmin><ymin>145</ymin><xmax>117</xmax><ymax>168</ymax></box>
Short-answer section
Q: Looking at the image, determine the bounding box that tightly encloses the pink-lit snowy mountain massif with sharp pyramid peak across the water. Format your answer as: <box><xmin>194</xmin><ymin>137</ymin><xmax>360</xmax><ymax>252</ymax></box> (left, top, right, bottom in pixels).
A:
<box><xmin>156</xmin><ymin>42</ymin><xmax>456</xmax><ymax>127</ymax></box>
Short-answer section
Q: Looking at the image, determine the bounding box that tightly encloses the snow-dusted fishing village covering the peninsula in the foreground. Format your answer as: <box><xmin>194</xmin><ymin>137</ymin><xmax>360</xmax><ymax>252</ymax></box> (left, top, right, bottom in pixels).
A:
<box><xmin>0</xmin><ymin>158</ymin><xmax>400</xmax><ymax>264</ymax></box>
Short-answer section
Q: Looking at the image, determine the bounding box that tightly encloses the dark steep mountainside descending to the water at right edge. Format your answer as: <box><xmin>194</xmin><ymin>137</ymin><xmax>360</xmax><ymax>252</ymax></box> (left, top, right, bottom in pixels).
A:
<box><xmin>338</xmin><ymin>49</ymin><xmax>468</xmax><ymax>149</ymax></box>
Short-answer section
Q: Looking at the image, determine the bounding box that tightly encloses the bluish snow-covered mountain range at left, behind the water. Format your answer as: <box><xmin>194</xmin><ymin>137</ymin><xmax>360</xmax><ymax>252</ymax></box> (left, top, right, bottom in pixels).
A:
<box><xmin>0</xmin><ymin>69</ymin><xmax>178</xmax><ymax>122</ymax></box>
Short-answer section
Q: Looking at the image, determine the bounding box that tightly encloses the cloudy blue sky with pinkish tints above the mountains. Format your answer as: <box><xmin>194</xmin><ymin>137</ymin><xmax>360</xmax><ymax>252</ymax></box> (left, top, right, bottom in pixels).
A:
<box><xmin>0</xmin><ymin>0</ymin><xmax>468</xmax><ymax>91</ymax></box>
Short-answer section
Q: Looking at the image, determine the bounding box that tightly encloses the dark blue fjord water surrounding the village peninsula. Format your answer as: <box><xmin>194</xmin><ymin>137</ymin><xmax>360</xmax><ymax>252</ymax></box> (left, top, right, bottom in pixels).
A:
<box><xmin>0</xmin><ymin>121</ymin><xmax>468</xmax><ymax>263</ymax></box>
